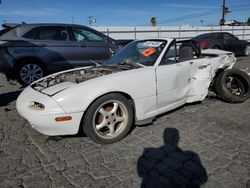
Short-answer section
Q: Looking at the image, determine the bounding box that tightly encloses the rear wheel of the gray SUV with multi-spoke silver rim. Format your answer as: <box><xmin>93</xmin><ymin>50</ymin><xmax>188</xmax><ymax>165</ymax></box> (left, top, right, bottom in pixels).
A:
<box><xmin>16</xmin><ymin>60</ymin><xmax>46</xmax><ymax>86</ymax></box>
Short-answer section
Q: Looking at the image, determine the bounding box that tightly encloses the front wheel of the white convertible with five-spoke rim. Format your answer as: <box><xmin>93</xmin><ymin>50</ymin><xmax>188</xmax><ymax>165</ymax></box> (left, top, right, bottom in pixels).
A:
<box><xmin>82</xmin><ymin>94</ymin><xmax>134</xmax><ymax>144</ymax></box>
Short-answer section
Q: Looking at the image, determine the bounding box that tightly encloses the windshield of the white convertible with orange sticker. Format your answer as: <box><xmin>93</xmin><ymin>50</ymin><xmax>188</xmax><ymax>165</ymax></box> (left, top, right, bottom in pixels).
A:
<box><xmin>106</xmin><ymin>40</ymin><xmax>167</xmax><ymax>66</ymax></box>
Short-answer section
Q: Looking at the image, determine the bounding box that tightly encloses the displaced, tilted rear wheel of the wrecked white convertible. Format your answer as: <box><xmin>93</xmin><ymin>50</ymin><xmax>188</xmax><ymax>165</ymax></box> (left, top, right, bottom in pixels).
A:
<box><xmin>214</xmin><ymin>69</ymin><xmax>250</xmax><ymax>103</ymax></box>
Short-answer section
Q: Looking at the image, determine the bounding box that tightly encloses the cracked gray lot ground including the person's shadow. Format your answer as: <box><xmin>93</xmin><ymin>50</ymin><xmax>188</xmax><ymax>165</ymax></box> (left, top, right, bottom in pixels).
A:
<box><xmin>0</xmin><ymin>58</ymin><xmax>250</xmax><ymax>188</ymax></box>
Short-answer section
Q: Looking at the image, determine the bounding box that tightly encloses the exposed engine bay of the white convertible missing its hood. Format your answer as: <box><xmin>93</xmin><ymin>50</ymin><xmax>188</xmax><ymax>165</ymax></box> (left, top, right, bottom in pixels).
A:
<box><xmin>32</xmin><ymin>66</ymin><xmax>122</xmax><ymax>91</ymax></box>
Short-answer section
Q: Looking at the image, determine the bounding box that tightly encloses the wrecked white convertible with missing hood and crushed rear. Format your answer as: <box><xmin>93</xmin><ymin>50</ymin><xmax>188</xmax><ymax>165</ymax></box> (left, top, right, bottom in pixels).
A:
<box><xmin>16</xmin><ymin>39</ymin><xmax>250</xmax><ymax>144</ymax></box>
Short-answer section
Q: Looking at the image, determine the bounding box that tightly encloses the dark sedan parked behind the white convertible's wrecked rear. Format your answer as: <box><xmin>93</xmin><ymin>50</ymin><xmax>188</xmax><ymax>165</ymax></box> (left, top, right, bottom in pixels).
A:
<box><xmin>193</xmin><ymin>32</ymin><xmax>250</xmax><ymax>56</ymax></box>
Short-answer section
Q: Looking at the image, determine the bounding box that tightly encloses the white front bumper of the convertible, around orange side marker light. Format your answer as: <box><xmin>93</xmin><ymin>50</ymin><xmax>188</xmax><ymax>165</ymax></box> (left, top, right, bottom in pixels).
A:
<box><xmin>16</xmin><ymin>87</ymin><xmax>83</xmax><ymax>136</ymax></box>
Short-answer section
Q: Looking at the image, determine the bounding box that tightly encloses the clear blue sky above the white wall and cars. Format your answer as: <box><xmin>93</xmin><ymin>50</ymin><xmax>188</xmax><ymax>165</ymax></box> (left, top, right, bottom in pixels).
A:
<box><xmin>0</xmin><ymin>0</ymin><xmax>250</xmax><ymax>26</ymax></box>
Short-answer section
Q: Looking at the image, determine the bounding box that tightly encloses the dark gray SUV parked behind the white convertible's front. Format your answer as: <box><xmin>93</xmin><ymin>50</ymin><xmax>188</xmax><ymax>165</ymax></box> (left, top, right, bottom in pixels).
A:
<box><xmin>0</xmin><ymin>24</ymin><xmax>123</xmax><ymax>85</ymax></box>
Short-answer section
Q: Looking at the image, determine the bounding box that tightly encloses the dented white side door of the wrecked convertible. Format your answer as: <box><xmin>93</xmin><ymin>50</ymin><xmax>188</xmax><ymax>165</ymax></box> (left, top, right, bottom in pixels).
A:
<box><xmin>156</xmin><ymin>42</ymin><xmax>192</xmax><ymax>112</ymax></box>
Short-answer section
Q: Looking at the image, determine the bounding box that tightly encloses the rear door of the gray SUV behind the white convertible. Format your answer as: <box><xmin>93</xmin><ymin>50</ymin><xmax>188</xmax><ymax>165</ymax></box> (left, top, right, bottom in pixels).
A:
<box><xmin>32</xmin><ymin>26</ymin><xmax>77</xmax><ymax>72</ymax></box>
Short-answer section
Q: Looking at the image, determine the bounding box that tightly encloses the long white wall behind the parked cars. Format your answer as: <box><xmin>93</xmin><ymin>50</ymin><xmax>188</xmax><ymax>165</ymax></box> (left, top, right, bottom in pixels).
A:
<box><xmin>93</xmin><ymin>26</ymin><xmax>250</xmax><ymax>41</ymax></box>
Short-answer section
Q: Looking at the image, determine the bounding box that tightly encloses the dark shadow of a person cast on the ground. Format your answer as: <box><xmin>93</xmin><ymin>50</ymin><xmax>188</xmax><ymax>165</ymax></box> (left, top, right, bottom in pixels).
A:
<box><xmin>137</xmin><ymin>128</ymin><xmax>208</xmax><ymax>188</ymax></box>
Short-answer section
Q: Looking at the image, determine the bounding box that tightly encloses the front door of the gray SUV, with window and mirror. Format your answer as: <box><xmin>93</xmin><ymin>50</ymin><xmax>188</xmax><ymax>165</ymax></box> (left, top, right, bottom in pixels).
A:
<box><xmin>68</xmin><ymin>27</ymin><xmax>114</xmax><ymax>66</ymax></box>
